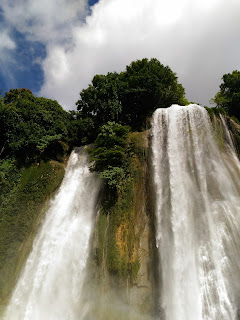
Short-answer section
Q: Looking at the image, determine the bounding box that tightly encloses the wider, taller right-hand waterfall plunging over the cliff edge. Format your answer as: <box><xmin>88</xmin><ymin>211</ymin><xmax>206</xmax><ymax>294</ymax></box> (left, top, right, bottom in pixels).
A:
<box><xmin>152</xmin><ymin>105</ymin><xmax>240</xmax><ymax>320</ymax></box>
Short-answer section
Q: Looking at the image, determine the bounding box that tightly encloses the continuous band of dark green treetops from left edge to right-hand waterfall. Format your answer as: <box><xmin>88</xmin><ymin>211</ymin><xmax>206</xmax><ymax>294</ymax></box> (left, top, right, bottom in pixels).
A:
<box><xmin>0</xmin><ymin>59</ymin><xmax>187</xmax><ymax>163</ymax></box>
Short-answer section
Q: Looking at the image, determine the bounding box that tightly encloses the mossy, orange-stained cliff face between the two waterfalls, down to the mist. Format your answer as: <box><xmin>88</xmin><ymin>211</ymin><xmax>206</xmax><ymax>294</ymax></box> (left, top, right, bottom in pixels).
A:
<box><xmin>86</xmin><ymin>132</ymin><xmax>154</xmax><ymax>319</ymax></box>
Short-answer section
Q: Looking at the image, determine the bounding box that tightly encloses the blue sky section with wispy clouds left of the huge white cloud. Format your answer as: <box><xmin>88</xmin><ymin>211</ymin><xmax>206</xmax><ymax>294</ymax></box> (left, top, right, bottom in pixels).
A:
<box><xmin>0</xmin><ymin>0</ymin><xmax>88</xmax><ymax>90</ymax></box>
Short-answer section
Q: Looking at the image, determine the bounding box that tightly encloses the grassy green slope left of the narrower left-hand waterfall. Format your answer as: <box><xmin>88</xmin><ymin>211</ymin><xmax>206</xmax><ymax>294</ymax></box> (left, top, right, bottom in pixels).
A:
<box><xmin>0</xmin><ymin>161</ymin><xmax>64</xmax><ymax>306</ymax></box>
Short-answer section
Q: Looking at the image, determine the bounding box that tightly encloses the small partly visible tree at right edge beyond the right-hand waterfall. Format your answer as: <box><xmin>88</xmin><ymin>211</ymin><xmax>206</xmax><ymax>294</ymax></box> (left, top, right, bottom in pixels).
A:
<box><xmin>213</xmin><ymin>70</ymin><xmax>240</xmax><ymax>120</ymax></box>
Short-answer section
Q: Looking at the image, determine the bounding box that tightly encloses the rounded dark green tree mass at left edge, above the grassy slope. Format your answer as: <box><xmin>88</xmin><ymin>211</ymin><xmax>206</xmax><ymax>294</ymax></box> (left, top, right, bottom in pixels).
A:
<box><xmin>0</xmin><ymin>89</ymin><xmax>71</xmax><ymax>160</ymax></box>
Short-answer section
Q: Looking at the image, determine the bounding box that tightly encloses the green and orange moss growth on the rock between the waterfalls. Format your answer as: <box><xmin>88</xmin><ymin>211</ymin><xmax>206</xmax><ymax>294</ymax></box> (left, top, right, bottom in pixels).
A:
<box><xmin>96</xmin><ymin>132</ymin><xmax>147</xmax><ymax>283</ymax></box>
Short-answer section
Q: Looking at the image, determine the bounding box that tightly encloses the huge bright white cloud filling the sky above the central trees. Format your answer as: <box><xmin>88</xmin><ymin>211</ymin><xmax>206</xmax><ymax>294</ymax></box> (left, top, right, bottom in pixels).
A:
<box><xmin>36</xmin><ymin>0</ymin><xmax>240</xmax><ymax>109</ymax></box>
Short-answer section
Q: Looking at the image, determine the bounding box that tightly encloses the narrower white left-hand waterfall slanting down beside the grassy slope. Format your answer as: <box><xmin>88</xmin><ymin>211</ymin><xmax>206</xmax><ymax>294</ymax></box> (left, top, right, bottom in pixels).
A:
<box><xmin>4</xmin><ymin>148</ymin><xmax>101</xmax><ymax>320</ymax></box>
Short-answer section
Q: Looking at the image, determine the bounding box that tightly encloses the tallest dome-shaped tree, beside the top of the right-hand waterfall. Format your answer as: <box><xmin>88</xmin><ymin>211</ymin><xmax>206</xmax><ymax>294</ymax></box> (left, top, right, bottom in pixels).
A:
<box><xmin>120</xmin><ymin>58</ymin><xmax>187</xmax><ymax>129</ymax></box>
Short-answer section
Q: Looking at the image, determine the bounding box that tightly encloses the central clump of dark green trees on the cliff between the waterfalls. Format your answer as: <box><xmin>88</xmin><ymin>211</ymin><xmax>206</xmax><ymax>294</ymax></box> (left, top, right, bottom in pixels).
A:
<box><xmin>76</xmin><ymin>59</ymin><xmax>187</xmax><ymax>132</ymax></box>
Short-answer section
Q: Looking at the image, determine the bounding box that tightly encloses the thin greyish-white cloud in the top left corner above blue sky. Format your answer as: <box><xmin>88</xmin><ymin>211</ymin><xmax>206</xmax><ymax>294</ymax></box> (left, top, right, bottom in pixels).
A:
<box><xmin>1</xmin><ymin>0</ymin><xmax>87</xmax><ymax>43</ymax></box>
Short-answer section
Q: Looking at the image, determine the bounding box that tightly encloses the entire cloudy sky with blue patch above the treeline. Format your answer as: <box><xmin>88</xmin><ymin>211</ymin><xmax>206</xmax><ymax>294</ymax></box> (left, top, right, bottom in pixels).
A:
<box><xmin>0</xmin><ymin>0</ymin><xmax>240</xmax><ymax>110</ymax></box>
